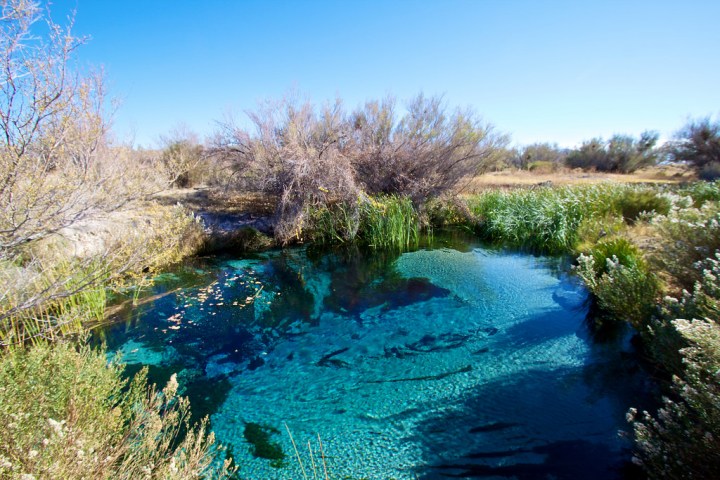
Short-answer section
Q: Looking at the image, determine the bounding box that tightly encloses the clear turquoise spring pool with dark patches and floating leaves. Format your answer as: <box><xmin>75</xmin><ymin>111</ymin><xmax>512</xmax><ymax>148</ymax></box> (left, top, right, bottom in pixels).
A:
<box><xmin>96</xmin><ymin>232</ymin><xmax>645</xmax><ymax>479</ymax></box>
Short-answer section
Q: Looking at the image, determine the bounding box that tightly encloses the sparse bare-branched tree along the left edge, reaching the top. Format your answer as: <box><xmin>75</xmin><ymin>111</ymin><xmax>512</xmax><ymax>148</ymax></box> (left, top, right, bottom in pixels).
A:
<box><xmin>0</xmin><ymin>0</ymin><xmax>165</xmax><ymax>345</ymax></box>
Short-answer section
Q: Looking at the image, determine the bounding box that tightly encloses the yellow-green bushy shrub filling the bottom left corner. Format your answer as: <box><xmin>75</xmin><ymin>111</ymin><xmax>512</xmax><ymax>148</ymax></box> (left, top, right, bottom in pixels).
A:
<box><xmin>0</xmin><ymin>344</ymin><xmax>232</xmax><ymax>479</ymax></box>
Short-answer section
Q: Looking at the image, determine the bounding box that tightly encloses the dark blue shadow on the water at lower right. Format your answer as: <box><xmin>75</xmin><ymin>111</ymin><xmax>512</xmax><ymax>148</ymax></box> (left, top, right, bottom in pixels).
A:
<box><xmin>412</xmin><ymin>318</ymin><xmax>653</xmax><ymax>480</ymax></box>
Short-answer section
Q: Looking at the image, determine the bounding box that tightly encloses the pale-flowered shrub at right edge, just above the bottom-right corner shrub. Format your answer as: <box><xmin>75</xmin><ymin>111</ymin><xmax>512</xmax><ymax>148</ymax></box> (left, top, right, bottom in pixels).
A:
<box><xmin>651</xmin><ymin>203</ymin><xmax>720</xmax><ymax>290</ymax></box>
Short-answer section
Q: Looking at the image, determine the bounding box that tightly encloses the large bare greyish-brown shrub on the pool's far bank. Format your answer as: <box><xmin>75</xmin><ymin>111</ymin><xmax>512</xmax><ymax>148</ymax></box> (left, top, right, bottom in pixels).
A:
<box><xmin>214</xmin><ymin>95</ymin><xmax>506</xmax><ymax>243</ymax></box>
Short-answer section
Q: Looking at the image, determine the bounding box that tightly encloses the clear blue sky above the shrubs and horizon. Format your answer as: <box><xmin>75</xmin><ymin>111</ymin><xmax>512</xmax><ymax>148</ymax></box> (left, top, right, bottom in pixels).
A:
<box><xmin>64</xmin><ymin>0</ymin><xmax>720</xmax><ymax>146</ymax></box>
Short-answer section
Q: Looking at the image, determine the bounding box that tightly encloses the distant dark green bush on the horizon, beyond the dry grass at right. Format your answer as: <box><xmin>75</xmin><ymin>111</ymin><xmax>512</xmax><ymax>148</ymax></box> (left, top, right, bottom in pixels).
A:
<box><xmin>565</xmin><ymin>132</ymin><xmax>658</xmax><ymax>173</ymax></box>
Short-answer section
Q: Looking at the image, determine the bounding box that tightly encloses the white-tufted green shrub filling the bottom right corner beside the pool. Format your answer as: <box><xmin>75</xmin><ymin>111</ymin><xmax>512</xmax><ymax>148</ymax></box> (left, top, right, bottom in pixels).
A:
<box><xmin>628</xmin><ymin>257</ymin><xmax>720</xmax><ymax>479</ymax></box>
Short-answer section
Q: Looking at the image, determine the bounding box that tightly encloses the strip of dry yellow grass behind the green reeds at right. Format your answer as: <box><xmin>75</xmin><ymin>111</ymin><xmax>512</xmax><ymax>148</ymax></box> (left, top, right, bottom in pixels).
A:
<box><xmin>467</xmin><ymin>165</ymin><xmax>696</xmax><ymax>193</ymax></box>
